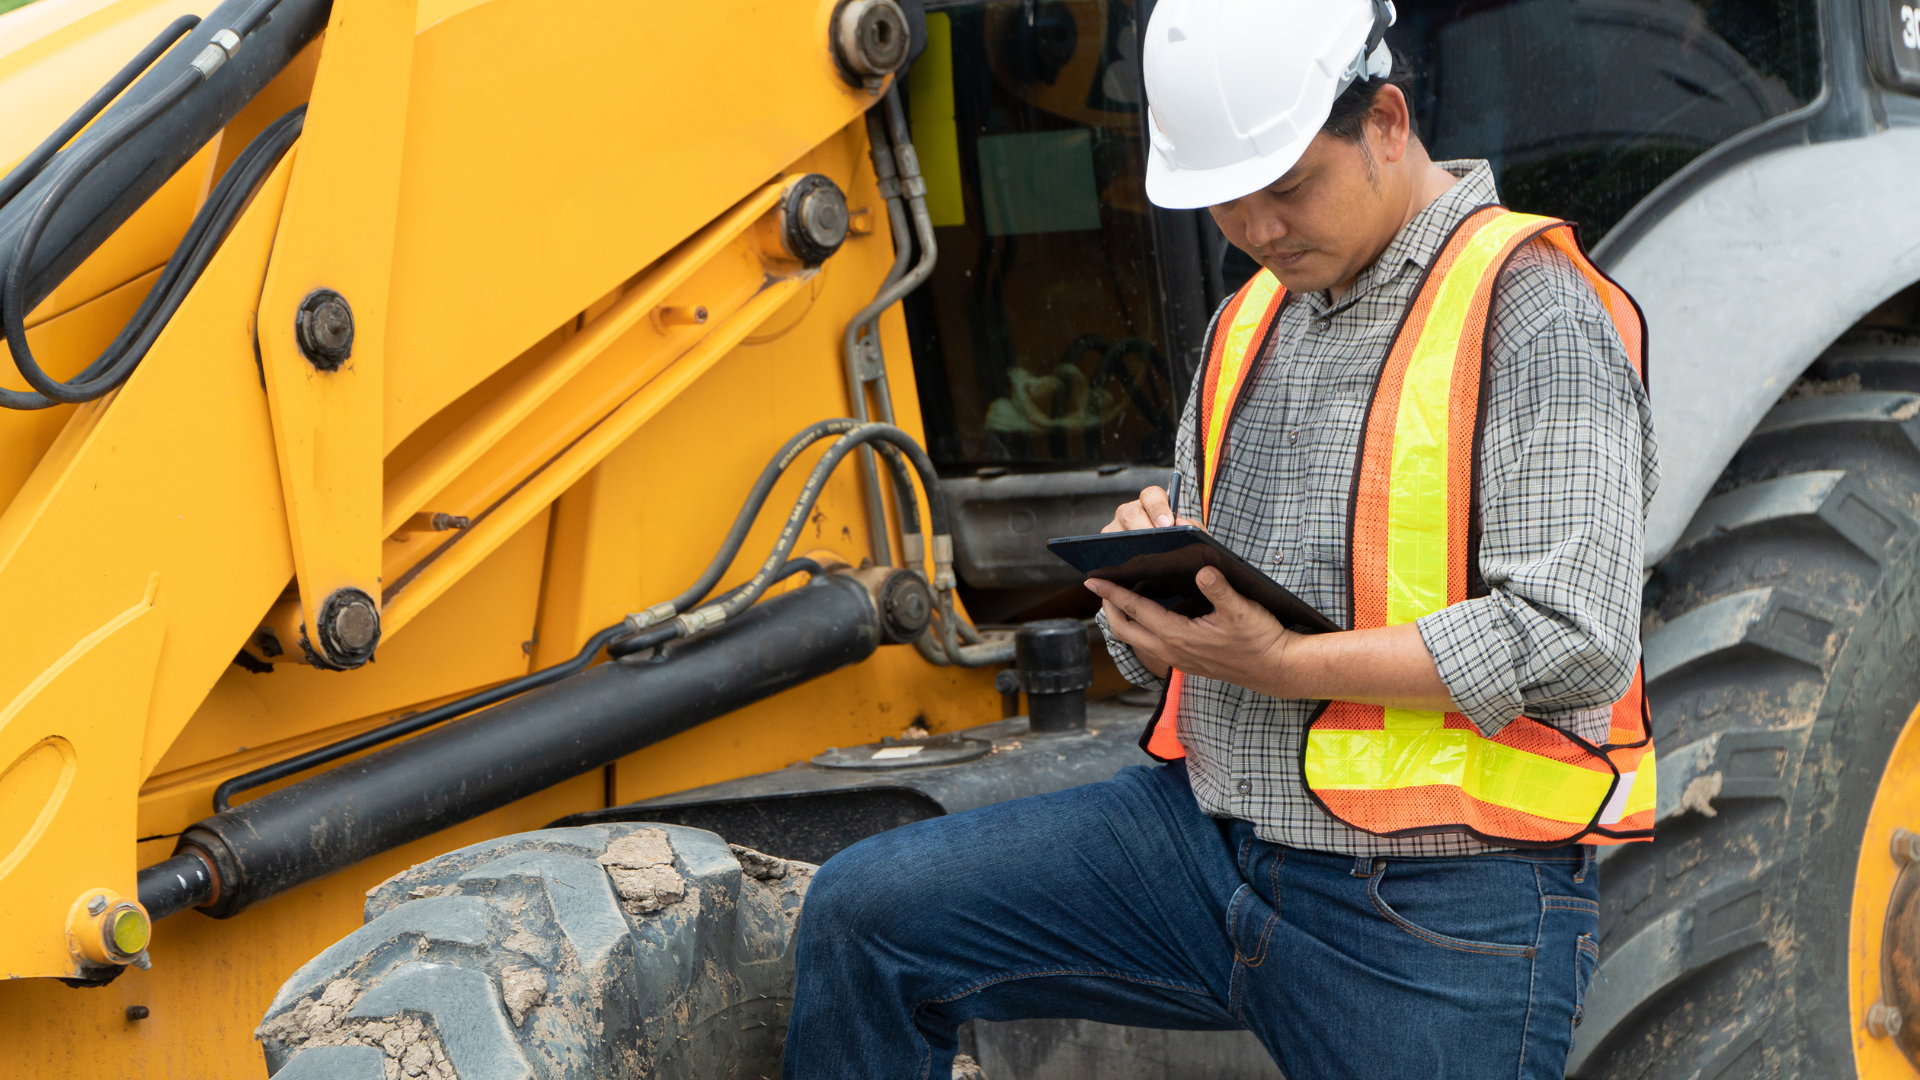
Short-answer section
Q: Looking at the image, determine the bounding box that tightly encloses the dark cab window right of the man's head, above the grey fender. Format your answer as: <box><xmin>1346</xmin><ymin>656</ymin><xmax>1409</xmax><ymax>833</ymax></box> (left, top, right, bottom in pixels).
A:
<box><xmin>1221</xmin><ymin>0</ymin><xmax>1820</xmax><ymax>288</ymax></box>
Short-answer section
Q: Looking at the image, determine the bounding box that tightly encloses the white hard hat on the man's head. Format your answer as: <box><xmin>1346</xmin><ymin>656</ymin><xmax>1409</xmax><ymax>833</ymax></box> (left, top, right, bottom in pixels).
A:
<box><xmin>1142</xmin><ymin>0</ymin><xmax>1394</xmax><ymax>209</ymax></box>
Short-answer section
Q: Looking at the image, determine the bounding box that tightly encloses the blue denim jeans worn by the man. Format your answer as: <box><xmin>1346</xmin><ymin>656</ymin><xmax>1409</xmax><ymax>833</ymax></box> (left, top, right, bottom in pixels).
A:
<box><xmin>785</xmin><ymin>763</ymin><xmax>1599</xmax><ymax>1080</ymax></box>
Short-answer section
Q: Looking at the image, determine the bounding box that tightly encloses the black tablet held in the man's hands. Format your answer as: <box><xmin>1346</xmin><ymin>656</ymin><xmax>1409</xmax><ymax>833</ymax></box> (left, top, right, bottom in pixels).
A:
<box><xmin>1046</xmin><ymin>525</ymin><xmax>1340</xmax><ymax>634</ymax></box>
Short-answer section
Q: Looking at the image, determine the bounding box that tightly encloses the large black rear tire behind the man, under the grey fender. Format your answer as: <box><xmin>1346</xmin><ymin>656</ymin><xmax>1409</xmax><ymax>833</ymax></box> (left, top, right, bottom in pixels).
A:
<box><xmin>1569</xmin><ymin>336</ymin><xmax>1920</xmax><ymax>1080</ymax></box>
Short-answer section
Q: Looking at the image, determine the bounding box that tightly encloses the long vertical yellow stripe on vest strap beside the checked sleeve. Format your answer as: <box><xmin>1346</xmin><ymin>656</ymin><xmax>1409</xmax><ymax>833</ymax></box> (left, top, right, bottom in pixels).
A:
<box><xmin>1386</xmin><ymin>213</ymin><xmax>1548</xmax><ymax>626</ymax></box>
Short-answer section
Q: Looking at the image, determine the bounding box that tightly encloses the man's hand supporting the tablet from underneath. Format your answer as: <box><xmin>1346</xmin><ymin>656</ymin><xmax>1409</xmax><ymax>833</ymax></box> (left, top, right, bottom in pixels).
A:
<box><xmin>1087</xmin><ymin>567</ymin><xmax>1300</xmax><ymax>696</ymax></box>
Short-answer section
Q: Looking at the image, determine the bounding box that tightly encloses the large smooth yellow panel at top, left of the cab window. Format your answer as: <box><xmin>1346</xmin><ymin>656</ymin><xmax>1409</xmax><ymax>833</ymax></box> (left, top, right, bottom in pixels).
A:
<box><xmin>386</xmin><ymin>0</ymin><xmax>874</xmax><ymax>448</ymax></box>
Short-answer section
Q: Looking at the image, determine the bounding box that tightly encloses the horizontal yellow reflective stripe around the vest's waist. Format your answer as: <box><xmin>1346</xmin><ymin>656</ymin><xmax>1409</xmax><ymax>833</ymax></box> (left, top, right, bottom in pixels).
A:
<box><xmin>1306</xmin><ymin>728</ymin><xmax>1605</xmax><ymax>824</ymax></box>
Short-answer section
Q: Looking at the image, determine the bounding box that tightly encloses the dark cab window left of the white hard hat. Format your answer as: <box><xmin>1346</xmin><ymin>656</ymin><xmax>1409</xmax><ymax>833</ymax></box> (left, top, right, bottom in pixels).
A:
<box><xmin>906</xmin><ymin>0</ymin><xmax>1177</xmax><ymax>475</ymax></box>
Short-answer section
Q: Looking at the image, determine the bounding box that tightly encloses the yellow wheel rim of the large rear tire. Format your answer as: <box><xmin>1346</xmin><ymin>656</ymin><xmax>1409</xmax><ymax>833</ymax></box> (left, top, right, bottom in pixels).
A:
<box><xmin>1847</xmin><ymin>691</ymin><xmax>1920</xmax><ymax>1080</ymax></box>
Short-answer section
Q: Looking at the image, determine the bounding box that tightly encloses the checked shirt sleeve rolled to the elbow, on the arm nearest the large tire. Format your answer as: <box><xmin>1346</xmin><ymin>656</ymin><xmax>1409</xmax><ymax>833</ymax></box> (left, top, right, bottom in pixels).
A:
<box><xmin>1417</xmin><ymin>246</ymin><xmax>1659</xmax><ymax>736</ymax></box>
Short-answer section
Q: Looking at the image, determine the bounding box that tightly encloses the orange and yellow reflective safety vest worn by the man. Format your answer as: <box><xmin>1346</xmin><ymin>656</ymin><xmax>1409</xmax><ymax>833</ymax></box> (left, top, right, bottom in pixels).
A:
<box><xmin>1140</xmin><ymin>206</ymin><xmax>1655</xmax><ymax>847</ymax></box>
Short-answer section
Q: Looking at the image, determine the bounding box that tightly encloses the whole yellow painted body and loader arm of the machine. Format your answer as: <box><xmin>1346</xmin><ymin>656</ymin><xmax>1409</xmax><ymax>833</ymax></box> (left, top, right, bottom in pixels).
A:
<box><xmin>0</xmin><ymin>0</ymin><xmax>998</xmax><ymax>1078</ymax></box>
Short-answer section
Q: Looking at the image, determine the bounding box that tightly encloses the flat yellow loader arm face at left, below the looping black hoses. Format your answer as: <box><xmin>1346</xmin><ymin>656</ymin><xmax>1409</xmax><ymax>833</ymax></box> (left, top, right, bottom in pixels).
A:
<box><xmin>0</xmin><ymin>153</ymin><xmax>292</xmax><ymax>799</ymax></box>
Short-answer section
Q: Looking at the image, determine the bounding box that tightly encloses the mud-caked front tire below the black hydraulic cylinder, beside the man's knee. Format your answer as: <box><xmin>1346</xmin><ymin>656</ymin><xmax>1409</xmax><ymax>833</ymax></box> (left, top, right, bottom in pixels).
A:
<box><xmin>255</xmin><ymin>824</ymin><xmax>814</xmax><ymax>1080</ymax></box>
